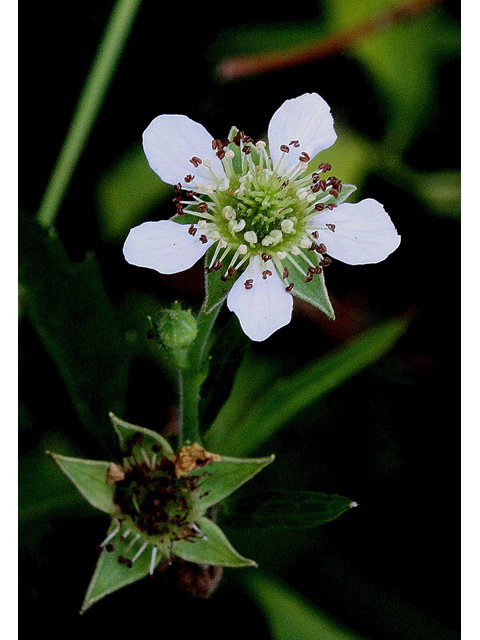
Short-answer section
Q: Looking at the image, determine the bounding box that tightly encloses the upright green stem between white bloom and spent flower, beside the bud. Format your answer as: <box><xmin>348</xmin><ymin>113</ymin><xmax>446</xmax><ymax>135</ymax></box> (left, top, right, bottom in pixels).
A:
<box><xmin>179</xmin><ymin>304</ymin><xmax>222</xmax><ymax>446</ymax></box>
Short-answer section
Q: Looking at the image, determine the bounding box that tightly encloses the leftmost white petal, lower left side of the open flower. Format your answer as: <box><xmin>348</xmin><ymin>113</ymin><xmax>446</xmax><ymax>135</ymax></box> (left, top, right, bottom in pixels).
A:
<box><xmin>123</xmin><ymin>220</ymin><xmax>213</xmax><ymax>274</ymax></box>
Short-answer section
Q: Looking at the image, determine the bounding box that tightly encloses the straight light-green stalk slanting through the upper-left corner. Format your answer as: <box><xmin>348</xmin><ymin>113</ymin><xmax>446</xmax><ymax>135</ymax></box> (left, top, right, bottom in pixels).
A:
<box><xmin>37</xmin><ymin>0</ymin><xmax>141</xmax><ymax>227</ymax></box>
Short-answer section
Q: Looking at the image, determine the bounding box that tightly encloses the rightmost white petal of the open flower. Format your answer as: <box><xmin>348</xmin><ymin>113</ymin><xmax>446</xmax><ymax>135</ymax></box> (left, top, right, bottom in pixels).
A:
<box><xmin>309</xmin><ymin>198</ymin><xmax>400</xmax><ymax>264</ymax></box>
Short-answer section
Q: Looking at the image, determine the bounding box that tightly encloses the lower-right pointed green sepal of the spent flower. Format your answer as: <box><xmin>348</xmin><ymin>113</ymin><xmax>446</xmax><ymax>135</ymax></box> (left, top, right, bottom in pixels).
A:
<box><xmin>173</xmin><ymin>516</ymin><xmax>257</xmax><ymax>567</ymax></box>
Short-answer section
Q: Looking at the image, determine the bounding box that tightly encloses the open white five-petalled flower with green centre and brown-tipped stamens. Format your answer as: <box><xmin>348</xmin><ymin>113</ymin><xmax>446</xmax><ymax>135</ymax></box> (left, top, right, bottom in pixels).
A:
<box><xmin>124</xmin><ymin>93</ymin><xmax>400</xmax><ymax>341</ymax></box>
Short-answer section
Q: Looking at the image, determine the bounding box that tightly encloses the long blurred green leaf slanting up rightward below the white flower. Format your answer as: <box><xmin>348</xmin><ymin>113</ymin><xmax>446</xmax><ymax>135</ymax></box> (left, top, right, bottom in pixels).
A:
<box><xmin>206</xmin><ymin>318</ymin><xmax>409</xmax><ymax>456</ymax></box>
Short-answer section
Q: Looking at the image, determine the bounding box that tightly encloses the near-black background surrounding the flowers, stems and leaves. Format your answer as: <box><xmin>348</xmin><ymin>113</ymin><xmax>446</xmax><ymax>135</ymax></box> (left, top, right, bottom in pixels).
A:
<box><xmin>19</xmin><ymin>0</ymin><xmax>460</xmax><ymax>640</ymax></box>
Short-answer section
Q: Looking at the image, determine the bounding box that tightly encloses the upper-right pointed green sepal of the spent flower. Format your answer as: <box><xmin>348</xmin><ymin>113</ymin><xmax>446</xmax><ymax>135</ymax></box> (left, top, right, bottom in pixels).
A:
<box><xmin>190</xmin><ymin>455</ymin><xmax>275</xmax><ymax>510</ymax></box>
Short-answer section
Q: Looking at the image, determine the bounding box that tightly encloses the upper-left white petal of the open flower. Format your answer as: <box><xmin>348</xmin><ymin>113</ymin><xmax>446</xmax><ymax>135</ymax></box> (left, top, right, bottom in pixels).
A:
<box><xmin>143</xmin><ymin>115</ymin><xmax>225</xmax><ymax>189</ymax></box>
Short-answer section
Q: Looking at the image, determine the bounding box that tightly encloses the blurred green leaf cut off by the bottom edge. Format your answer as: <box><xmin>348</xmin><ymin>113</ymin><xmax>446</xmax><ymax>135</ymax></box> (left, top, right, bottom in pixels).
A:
<box><xmin>247</xmin><ymin>575</ymin><xmax>368</xmax><ymax>640</ymax></box>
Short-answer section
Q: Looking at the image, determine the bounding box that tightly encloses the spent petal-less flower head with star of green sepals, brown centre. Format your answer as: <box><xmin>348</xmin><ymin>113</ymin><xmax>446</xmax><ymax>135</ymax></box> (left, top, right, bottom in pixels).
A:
<box><xmin>50</xmin><ymin>414</ymin><xmax>274</xmax><ymax>612</ymax></box>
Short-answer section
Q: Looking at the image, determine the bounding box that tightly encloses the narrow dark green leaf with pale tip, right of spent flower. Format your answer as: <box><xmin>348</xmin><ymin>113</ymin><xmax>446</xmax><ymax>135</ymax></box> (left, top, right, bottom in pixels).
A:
<box><xmin>222</xmin><ymin>491</ymin><xmax>356</xmax><ymax>529</ymax></box>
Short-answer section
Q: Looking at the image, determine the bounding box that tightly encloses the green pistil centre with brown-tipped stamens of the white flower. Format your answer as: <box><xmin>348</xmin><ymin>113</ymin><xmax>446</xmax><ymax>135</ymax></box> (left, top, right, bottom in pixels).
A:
<box><xmin>174</xmin><ymin>128</ymin><xmax>342</xmax><ymax>291</ymax></box>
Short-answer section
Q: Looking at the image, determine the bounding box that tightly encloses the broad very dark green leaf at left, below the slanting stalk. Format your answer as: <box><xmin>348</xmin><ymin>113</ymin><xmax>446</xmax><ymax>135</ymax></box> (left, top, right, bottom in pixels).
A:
<box><xmin>19</xmin><ymin>211</ymin><xmax>131</xmax><ymax>447</ymax></box>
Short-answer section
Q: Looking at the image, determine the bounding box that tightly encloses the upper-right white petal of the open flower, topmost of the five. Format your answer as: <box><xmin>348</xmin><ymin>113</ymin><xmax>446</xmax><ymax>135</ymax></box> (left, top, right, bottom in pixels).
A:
<box><xmin>268</xmin><ymin>93</ymin><xmax>337</xmax><ymax>175</ymax></box>
